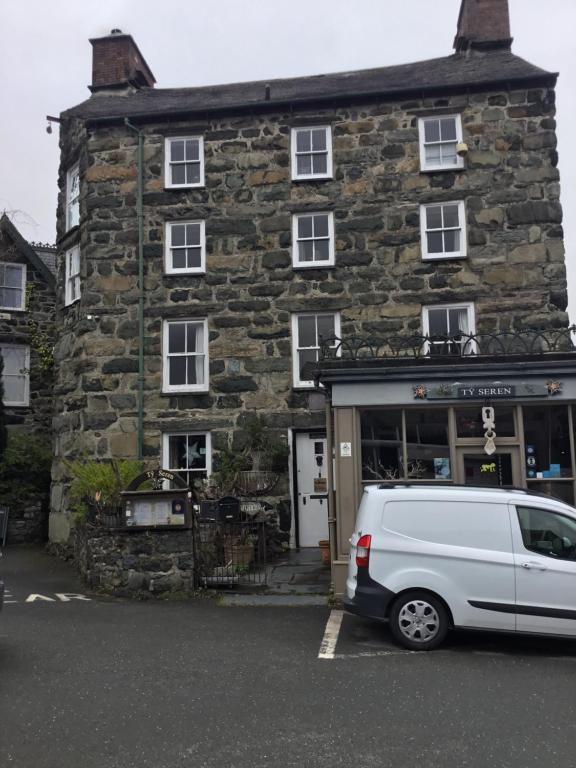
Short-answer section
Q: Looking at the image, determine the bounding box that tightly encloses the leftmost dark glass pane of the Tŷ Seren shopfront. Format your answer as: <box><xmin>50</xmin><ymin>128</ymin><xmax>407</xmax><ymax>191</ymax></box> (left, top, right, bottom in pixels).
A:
<box><xmin>360</xmin><ymin>411</ymin><xmax>404</xmax><ymax>482</ymax></box>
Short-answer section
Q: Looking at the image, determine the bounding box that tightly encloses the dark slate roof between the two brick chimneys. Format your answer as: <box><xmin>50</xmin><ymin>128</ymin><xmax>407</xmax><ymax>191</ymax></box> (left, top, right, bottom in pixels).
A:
<box><xmin>62</xmin><ymin>49</ymin><xmax>556</xmax><ymax>120</ymax></box>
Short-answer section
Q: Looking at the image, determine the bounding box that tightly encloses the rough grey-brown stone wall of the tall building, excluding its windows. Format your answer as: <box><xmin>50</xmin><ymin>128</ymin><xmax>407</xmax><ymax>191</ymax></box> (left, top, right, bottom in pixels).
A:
<box><xmin>52</xmin><ymin>84</ymin><xmax>567</xmax><ymax>537</ymax></box>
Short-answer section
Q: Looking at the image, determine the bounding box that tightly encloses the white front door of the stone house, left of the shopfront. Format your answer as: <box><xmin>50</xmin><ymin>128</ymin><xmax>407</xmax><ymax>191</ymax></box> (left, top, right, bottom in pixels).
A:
<box><xmin>296</xmin><ymin>432</ymin><xmax>328</xmax><ymax>547</ymax></box>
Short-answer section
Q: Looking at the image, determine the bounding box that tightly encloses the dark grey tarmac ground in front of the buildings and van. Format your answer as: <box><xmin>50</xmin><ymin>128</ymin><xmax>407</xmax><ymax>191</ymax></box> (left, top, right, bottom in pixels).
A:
<box><xmin>0</xmin><ymin>549</ymin><xmax>576</xmax><ymax>768</ymax></box>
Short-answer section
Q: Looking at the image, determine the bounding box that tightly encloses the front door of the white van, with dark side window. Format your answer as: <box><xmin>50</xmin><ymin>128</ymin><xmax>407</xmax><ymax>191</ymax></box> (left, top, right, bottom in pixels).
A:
<box><xmin>511</xmin><ymin>497</ymin><xmax>576</xmax><ymax>637</ymax></box>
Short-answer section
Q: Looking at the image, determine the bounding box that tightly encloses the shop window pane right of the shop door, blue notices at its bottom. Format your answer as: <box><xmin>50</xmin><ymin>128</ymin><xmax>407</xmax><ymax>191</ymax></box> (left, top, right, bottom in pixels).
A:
<box><xmin>520</xmin><ymin>405</ymin><xmax>572</xmax><ymax>476</ymax></box>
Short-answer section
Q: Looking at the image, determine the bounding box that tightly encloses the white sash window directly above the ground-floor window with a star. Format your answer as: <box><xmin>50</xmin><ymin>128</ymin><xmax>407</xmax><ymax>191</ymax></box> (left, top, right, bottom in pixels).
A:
<box><xmin>162</xmin><ymin>320</ymin><xmax>208</xmax><ymax>392</ymax></box>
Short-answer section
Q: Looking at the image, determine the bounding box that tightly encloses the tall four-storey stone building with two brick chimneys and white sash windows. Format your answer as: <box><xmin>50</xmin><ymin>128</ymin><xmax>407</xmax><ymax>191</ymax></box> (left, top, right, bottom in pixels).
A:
<box><xmin>51</xmin><ymin>0</ymin><xmax>568</xmax><ymax>546</ymax></box>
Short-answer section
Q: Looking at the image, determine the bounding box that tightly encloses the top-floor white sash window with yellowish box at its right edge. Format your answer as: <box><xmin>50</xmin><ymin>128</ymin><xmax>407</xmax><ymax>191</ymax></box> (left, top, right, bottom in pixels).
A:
<box><xmin>418</xmin><ymin>115</ymin><xmax>464</xmax><ymax>171</ymax></box>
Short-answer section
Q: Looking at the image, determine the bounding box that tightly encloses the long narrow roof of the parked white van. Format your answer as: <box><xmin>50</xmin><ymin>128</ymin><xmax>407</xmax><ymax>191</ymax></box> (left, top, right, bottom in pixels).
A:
<box><xmin>364</xmin><ymin>483</ymin><xmax>575</xmax><ymax>512</ymax></box>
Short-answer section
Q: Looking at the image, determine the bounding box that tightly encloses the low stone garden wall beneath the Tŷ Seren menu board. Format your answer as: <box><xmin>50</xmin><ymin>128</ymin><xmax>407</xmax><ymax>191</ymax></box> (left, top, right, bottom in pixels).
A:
<box><xmin>75</xmin><ymin>526</ymin><xmax>194</xmax><ymax>596</ymax></box>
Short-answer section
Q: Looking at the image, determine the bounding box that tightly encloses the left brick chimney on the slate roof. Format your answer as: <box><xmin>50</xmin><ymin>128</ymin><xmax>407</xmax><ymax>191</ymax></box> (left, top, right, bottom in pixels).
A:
<box><xmin>88</xmin><ymin>29</ymin><xmax>156</xmax><ymax>93</ymax></box>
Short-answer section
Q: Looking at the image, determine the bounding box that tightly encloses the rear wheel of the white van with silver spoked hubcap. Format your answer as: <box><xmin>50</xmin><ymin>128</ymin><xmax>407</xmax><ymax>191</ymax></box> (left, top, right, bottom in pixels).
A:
<box><xmin>390</xmin><ymin>591</ymin><xmax>449</xmax><ymax>651</ymax></box>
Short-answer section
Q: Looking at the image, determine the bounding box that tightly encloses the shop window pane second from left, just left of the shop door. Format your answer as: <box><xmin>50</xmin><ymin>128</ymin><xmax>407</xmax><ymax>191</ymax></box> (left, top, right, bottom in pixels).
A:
<box><xmin>406</xmin><ymin>409</ymin><xmax>452</xmax><ymax>480</ymax></box>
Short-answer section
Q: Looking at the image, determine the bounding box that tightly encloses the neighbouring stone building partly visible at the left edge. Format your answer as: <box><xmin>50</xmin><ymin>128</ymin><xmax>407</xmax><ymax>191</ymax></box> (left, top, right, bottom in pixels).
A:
<box><xmin>0</xmin><ymin>214</ymin><xmax>56</xmax><ymax>543</ymax></box>
